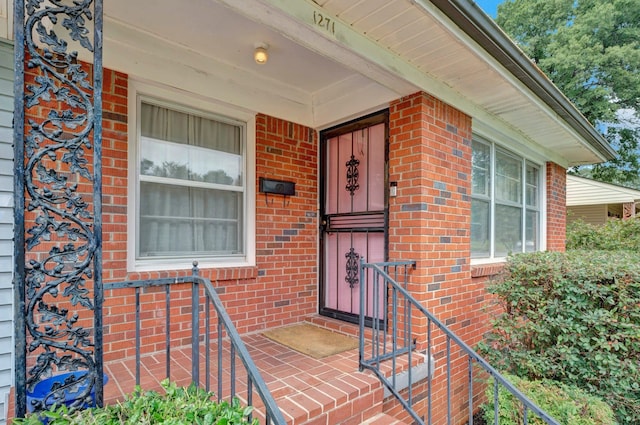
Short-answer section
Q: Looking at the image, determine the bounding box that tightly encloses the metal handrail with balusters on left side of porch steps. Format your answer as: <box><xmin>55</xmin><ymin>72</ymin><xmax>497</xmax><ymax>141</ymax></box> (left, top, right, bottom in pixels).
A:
<box><xmin>104</xmin><ymin>262</ymin><xmax>286</xmax><ymax>425</ymax></box>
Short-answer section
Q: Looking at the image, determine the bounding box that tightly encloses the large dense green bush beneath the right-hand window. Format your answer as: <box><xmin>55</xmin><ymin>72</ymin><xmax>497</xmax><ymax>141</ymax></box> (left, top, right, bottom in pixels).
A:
<box><xmin>479</xmin><ymin>251</ymin><xmax>640</xmax><ymax>424</ymax></box>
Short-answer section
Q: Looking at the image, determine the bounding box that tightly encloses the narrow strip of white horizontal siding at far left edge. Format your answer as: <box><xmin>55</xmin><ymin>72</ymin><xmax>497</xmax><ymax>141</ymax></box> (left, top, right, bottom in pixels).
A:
<box><xmin>0</xmin><ymin>40</ymin><xmax>13</xmax><ymax>425</ymax></box>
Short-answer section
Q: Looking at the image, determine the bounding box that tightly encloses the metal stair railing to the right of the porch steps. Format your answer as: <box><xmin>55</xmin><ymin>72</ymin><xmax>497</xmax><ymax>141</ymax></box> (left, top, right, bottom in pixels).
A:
<box><xmin>360</xmin><ymin>259</ymin><xmax>558</xmax><ymax>425</ymax></box>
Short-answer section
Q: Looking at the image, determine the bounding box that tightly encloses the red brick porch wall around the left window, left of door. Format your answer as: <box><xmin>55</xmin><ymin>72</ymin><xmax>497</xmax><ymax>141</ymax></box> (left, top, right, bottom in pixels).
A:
<box><xmin>103</xmin><ymin>108</ymin><xmax>318</xmax><ymax>360</ymax></box>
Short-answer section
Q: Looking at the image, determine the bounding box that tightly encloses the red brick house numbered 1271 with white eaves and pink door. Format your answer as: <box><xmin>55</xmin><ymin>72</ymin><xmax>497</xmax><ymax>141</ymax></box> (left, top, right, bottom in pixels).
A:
<box><xmin>5</xmin><ymin>0</ymin><xmax>613</xmax><ymax>424</ymax></box>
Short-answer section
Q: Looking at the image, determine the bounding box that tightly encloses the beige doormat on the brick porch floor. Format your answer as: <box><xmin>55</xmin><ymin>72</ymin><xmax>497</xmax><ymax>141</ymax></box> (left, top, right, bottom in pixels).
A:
<box><xmin>263</xmin><ymin>323</ymin><xmax>358</xmax><ymax>359</ymax></box>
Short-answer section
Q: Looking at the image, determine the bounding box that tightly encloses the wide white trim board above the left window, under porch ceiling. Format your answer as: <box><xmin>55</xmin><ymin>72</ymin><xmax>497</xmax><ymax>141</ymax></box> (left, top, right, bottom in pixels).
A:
<box><xmin>104</xmin><ymin>17</ymin><xmax>313</xmax><ymax>125</ymax></box>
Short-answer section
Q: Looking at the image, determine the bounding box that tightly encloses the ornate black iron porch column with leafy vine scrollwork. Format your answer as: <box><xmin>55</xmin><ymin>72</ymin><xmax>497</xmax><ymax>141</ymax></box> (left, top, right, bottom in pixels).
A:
<box><xmin>14</xmin><ymin>0</ymin><xmax>104</xmax><ymax>417</ymax></box>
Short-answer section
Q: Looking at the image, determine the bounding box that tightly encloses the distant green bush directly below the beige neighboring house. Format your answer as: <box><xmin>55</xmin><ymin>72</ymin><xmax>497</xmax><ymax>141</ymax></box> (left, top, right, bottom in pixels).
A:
<box><xmin>567</xmin><ymin>218</ymin><xmax>640</xmax><ymax>252</ymax></box>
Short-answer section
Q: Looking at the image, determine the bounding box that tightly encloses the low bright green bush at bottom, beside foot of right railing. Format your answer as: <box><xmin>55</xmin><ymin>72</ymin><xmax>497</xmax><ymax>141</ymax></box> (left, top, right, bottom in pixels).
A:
<box><xmin>484</xmin><ymin>375</ymin><xmax>616</xmax><ymax>425</ymax></box>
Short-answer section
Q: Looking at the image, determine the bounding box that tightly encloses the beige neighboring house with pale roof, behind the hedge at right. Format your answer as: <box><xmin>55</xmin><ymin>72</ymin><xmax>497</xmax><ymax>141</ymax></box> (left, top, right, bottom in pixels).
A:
<box><xmin>567</xmin><ymin>175</ymin><xmax>640</xmax><ymax>224</ymax></box>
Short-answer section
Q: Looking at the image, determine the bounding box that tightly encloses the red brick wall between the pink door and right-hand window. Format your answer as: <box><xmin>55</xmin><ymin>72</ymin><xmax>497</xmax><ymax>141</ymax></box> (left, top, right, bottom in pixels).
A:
<box><xmin>389</xmin><ymin>93</ymin><xmax>487</xmax><ymax>423</ymax></box>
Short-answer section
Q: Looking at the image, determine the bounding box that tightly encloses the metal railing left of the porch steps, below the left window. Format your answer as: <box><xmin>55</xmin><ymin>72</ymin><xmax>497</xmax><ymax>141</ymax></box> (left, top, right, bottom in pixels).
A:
<box><xmin>104</xmin><ymin>262</ymin><xmax>286</xmax><ymax>425</ymax></box>
